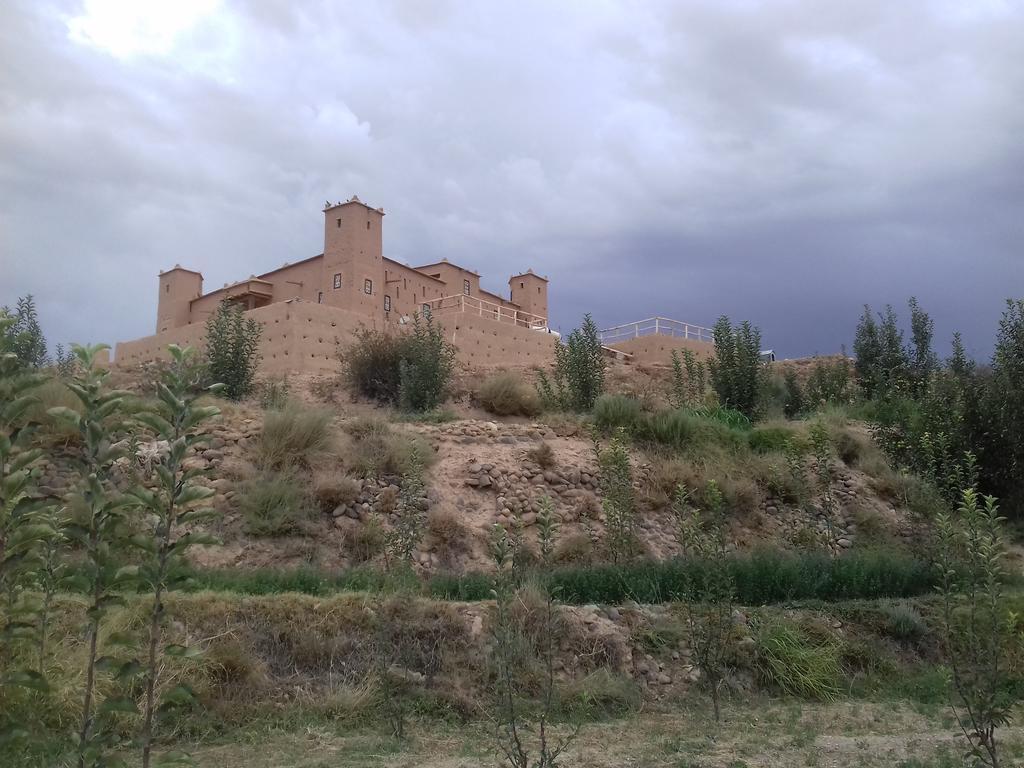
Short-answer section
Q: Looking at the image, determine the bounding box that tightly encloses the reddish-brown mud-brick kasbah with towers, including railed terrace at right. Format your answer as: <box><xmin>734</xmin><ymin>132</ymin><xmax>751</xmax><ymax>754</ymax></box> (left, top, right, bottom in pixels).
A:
<box><xmin>115</xmin><ymin>197</ymin><xmax>712</xmax><ymax>374</ymax></box>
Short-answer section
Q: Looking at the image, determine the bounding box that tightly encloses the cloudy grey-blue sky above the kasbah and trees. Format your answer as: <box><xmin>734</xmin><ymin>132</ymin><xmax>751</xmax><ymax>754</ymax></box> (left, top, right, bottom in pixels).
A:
<box><xmin>0</xmin><ymin>0</ymin><xmax>1024</xmax><ymax>357</ymax></box>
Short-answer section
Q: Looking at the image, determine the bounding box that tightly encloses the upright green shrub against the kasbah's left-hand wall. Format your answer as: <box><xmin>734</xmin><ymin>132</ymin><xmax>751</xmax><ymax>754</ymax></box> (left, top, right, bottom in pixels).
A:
<box><xmin>206</xmin><ymin>299</ymin><xmax>263</xmax><ymax>400</ymax></box>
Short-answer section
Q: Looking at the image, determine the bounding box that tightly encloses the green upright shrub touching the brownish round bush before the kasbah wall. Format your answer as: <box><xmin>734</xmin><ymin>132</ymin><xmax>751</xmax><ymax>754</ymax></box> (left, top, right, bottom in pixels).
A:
<box><xmin>398</xmin><ymin>313</ymin><xmax>455</xmax><ymax>413</ymax></box>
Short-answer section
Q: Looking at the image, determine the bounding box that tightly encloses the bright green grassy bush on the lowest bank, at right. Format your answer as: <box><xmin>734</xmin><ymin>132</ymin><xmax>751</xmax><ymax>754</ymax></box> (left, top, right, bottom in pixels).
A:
<box><xmin>756</xmin><ymin>620</ymin><xmax>843</xmax><ymax>701</ymax></box>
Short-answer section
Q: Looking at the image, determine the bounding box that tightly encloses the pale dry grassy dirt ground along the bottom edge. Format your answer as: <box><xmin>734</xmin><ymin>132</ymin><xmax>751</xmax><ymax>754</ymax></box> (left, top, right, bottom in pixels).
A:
<box><xmin>193</xmin><ymin>700</ymin><xmax>1024</xmax><ymax>768</ymax></box>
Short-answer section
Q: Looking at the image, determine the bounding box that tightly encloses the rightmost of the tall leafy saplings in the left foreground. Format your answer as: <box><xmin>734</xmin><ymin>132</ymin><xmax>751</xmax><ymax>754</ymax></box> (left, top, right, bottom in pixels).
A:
<box><xmin>132</xmin><ymin>344</ymin><xmax>220</xmax><ymax>768</ymax></box>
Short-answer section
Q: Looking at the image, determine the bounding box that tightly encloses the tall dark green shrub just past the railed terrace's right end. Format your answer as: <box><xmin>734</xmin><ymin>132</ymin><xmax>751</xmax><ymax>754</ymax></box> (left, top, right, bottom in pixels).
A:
<box><xmin>709</xmin><ymin>315</ymin><xmax>767</xmax><ymax>419</ymax></box>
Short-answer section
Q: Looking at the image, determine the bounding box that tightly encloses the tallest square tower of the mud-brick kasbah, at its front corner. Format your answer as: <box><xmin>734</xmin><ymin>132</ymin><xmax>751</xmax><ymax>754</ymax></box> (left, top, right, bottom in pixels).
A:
<box><xmin>322</xmin><ymin>196</ymin><xmax>384</xmax><ymax>317</ymax></box>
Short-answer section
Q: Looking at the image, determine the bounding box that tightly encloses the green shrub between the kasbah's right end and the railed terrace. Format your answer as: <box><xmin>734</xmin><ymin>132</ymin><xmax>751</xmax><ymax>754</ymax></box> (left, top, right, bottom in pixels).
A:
<box><xmin>537</xmin><ymin>314</ymin><xmax>604</xmax><ymax>413</ymax></box>
